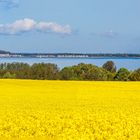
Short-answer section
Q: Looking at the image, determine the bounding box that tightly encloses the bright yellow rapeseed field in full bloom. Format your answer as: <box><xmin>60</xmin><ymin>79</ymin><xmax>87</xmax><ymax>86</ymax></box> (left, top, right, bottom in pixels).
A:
<box><xmin>0</xmin><ymin>80</ymin><xmax>140</xmax><ymax>140</ymax></box>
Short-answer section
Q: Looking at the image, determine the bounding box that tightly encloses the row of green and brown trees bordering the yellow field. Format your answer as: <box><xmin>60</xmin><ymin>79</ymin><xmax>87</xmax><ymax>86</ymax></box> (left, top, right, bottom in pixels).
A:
<box><xmin>0</xmin><ymin>61</ymin><xmax>140</xmax><ymax>81</ymax></box>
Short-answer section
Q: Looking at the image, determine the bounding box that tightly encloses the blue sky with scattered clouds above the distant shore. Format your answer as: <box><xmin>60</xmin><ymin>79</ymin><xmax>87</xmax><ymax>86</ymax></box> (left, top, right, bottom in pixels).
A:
<box><xmin>0</xmin><ymin>0</ymin><xmax>140</xmax><ymax>53</ymax></box>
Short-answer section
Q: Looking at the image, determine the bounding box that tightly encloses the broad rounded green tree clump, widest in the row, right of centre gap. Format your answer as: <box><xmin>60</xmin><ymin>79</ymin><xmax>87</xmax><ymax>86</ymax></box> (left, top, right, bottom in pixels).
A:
<box><xmin>60</xmin><ymin>63</ymin><xmax>113</xmax><ymax>81</ymax></box>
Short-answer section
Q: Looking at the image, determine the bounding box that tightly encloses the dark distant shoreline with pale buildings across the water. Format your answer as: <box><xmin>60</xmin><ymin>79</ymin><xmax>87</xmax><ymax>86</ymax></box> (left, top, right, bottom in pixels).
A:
<box><xmin>0</xmin><ymin>51</ymin><xmax>140</xmax><ymax>59</ymax></box>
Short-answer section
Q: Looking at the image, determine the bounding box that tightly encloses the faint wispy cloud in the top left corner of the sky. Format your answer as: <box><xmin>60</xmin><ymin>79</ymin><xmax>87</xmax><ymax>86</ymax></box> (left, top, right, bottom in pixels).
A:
<box><xmin>0</xmin><ymin>0</ymin><xmax>19</xmax><ymax>8</ymax></box>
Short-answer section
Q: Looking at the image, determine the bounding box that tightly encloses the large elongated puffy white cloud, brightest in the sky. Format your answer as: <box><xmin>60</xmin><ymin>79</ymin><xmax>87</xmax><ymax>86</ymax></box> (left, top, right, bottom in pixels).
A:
<box><xmin>0</xmin><ymin>18</ymin><xmax>72</xmax><ymax>35</ymax></box>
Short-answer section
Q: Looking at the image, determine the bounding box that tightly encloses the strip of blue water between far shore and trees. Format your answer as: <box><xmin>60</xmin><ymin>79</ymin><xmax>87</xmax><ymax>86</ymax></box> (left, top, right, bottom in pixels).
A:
<box><xmin>0</xmin><ymin>58</ymin><xmax>140</xmax><ymax>70</ymax></box>
